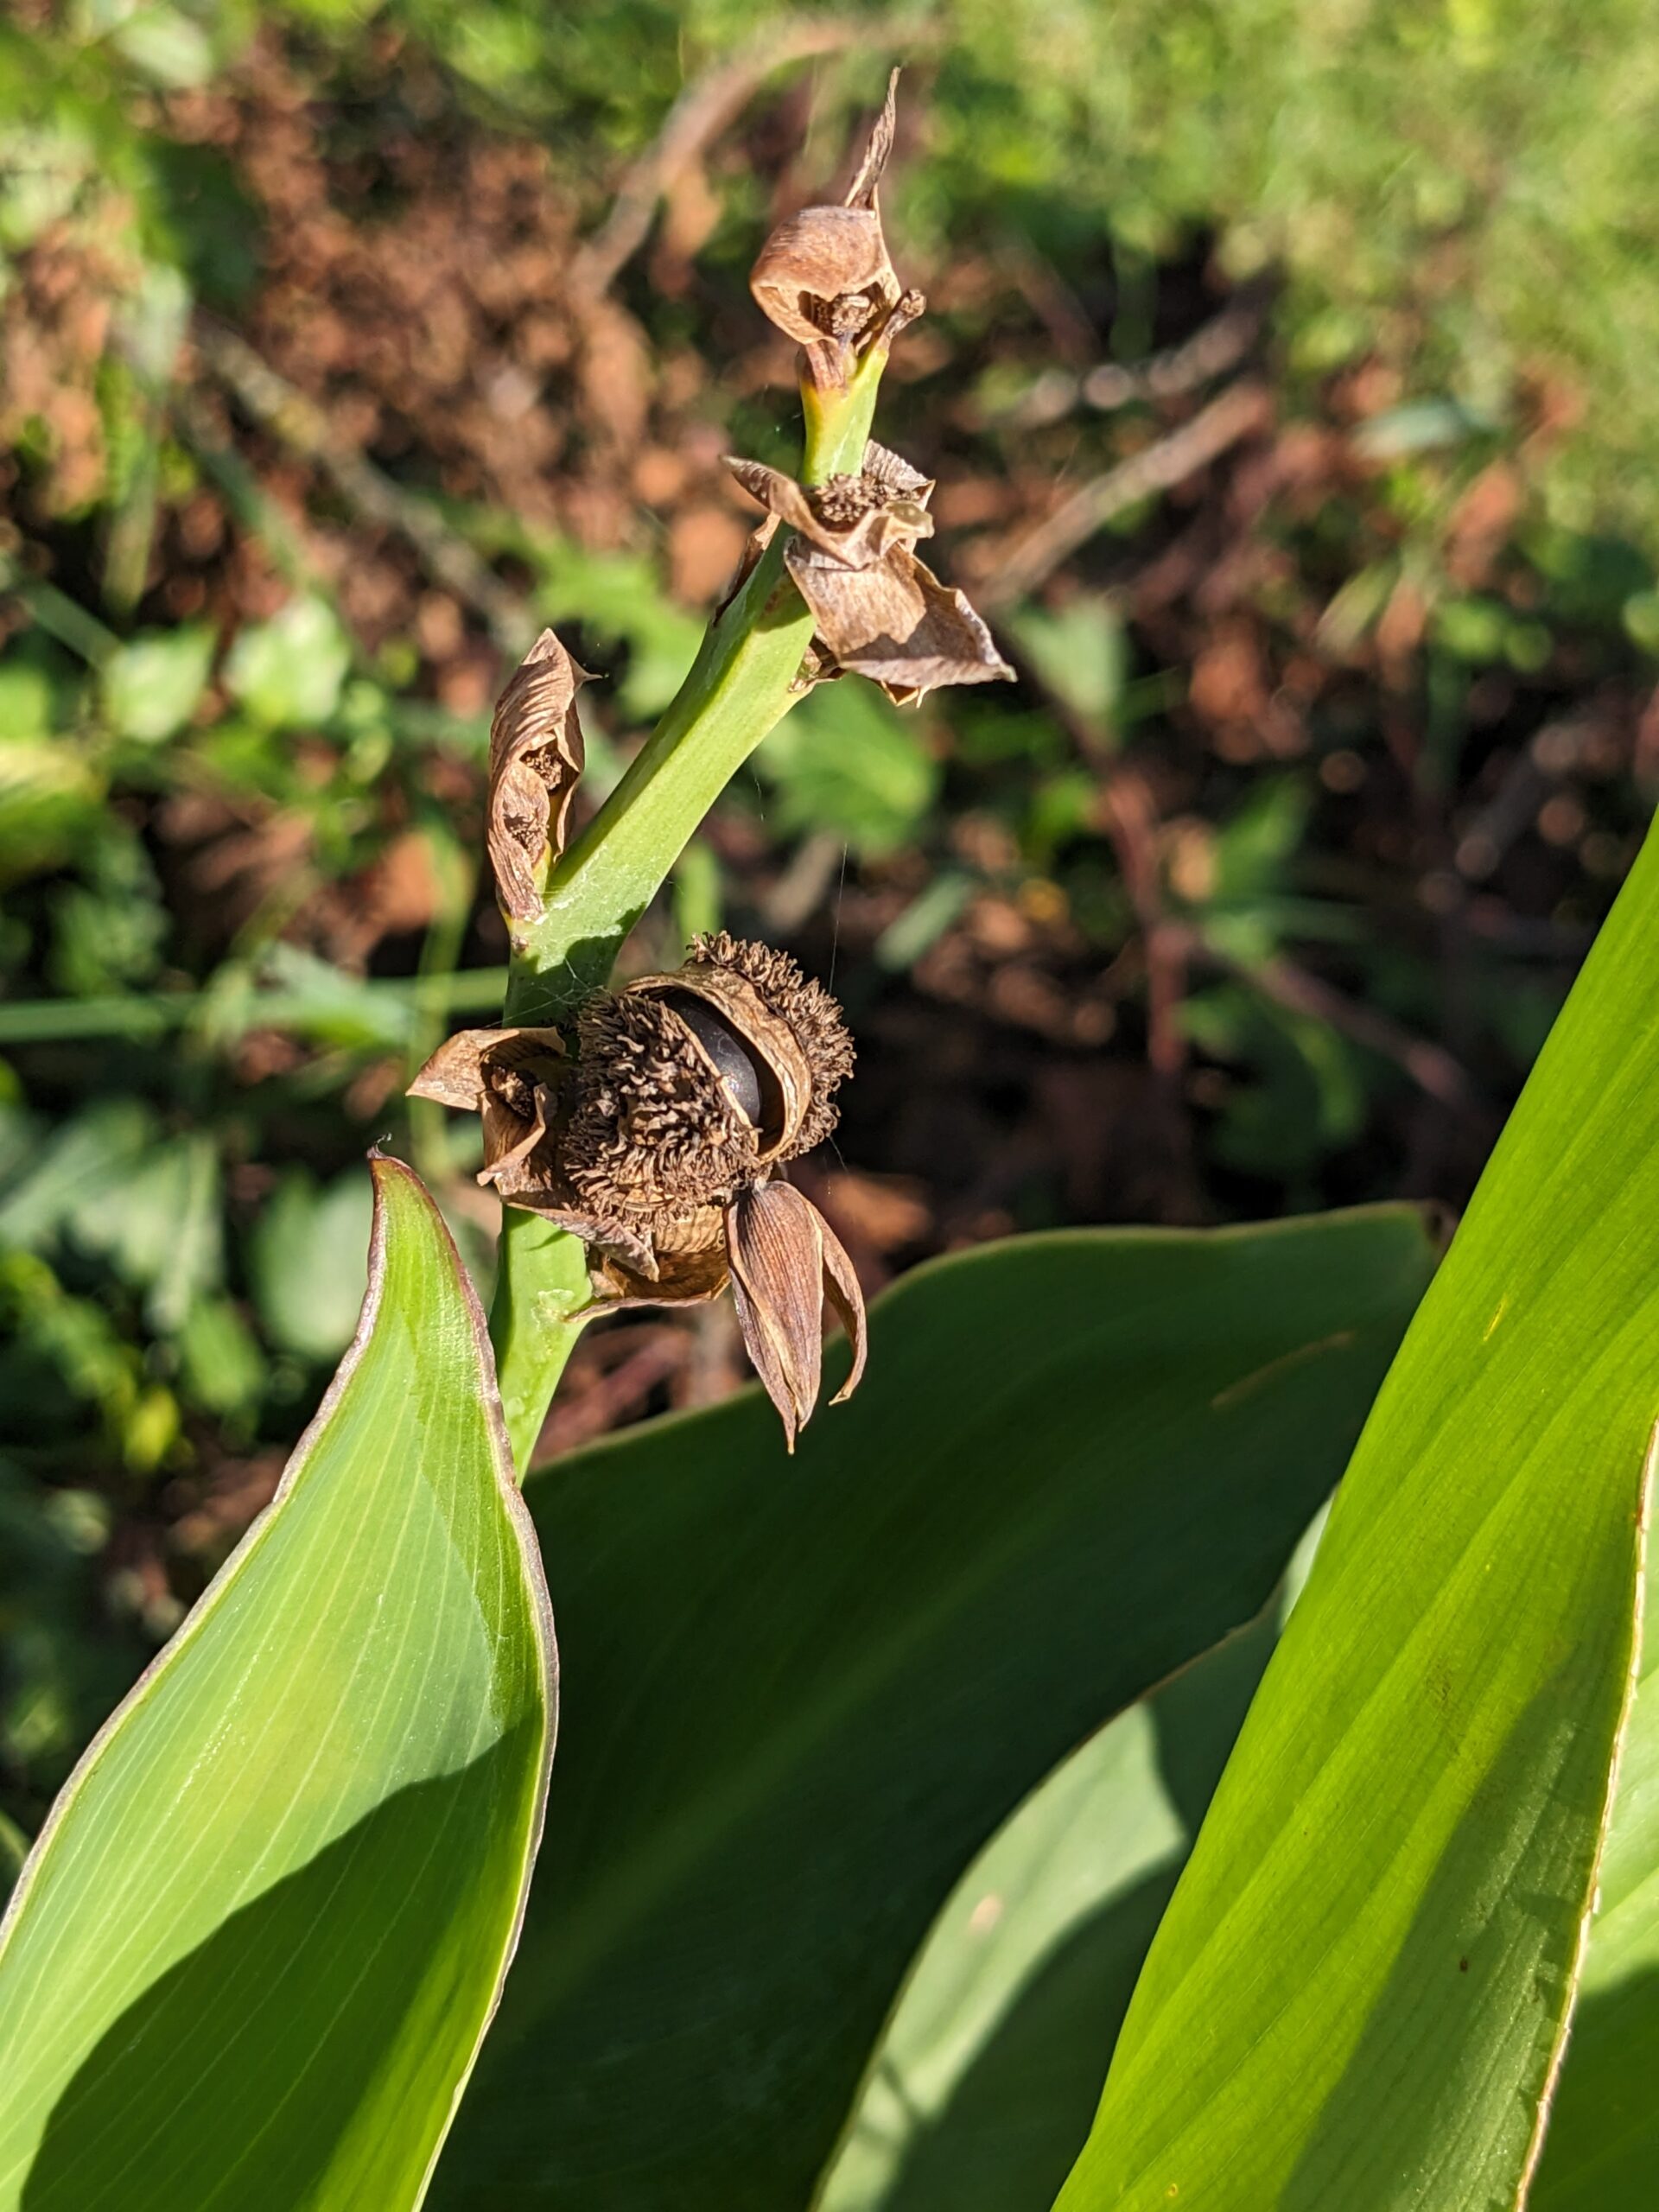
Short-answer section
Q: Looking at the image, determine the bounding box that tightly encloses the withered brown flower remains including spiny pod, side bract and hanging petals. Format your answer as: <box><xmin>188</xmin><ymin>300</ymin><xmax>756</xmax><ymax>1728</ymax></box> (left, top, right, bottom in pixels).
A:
<box><xmin>411</xmin><ymin>931</ymin><xmax>865</xmax><ymax>1449</ymax></box>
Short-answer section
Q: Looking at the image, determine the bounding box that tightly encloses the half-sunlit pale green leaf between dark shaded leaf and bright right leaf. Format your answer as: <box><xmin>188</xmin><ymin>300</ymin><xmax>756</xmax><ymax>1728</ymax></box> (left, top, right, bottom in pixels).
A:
<box><xmin>814</xmin><ymin>1513</ymin><xmax>1325</xmax><ymax>2212</ymax></box>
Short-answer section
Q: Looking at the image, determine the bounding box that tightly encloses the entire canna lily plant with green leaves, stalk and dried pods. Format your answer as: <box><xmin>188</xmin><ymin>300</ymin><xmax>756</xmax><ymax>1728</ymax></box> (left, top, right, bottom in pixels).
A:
<box><xmin>0</xmin><ymin>64</ymin><xmax>1659</xmax><ymax>2212</ymax></box>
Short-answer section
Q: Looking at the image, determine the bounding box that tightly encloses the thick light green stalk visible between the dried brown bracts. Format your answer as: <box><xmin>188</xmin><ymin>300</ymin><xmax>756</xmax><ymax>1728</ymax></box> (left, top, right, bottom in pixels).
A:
<box><xmin>489</xmin><ymin>354</ymin><xmax>885</xmax><ymax>1473</ymax></box>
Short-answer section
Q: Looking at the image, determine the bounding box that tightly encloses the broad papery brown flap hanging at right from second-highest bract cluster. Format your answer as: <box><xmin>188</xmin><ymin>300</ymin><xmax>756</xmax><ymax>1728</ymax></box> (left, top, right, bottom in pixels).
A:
<box><xmin>783</xmin><ymin>537</ymin><xmax>1013</xmax><ymax>702</ymax></box>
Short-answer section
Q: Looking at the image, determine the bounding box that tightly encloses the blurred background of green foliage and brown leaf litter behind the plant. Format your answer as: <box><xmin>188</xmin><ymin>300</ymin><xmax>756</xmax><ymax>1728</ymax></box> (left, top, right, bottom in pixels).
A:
<box><xmin>0</xmin><ymin>0</ymin><xmax>1659</xmax><ymax>1840</ymax></box>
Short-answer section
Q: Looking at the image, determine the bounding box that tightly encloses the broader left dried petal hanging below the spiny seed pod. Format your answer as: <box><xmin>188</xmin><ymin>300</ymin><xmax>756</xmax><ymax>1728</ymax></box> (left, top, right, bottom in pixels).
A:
<box><xmin>726</xmin><ymin>1184</ymin><xmax>823</xmax><ymax>1451</ymax></box>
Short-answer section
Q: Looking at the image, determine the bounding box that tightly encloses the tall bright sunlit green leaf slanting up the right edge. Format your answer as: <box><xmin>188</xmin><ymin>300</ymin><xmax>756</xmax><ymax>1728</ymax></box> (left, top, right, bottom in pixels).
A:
<box><xmin>1059</xmin><ymin>841</ymin><xmax>1659</xmax><ymax>2212</ymax></box>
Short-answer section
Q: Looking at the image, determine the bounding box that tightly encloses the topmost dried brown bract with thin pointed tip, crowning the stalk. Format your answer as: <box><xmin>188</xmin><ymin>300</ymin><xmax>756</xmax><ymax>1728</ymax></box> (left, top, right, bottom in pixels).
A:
<box><xmin>750</xmin><ymin>71</ymin><xmax>925</xmax><ymax>390</ymax></box>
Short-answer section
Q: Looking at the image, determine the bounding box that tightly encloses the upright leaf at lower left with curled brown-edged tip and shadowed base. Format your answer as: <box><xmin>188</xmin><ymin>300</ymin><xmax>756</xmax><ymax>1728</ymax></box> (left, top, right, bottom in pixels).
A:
<box><xmin>0</xmin><ymin>1161</ymin><xmax>553</xmax><ymax>2212</ymax></box>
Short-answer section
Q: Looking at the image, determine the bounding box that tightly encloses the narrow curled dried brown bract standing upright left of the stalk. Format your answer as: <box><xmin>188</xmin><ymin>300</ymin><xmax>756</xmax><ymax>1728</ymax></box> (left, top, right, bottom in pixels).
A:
<box><xmin>489</xmin><ymin>631</ymin><xmax>588</xmax><ymax>923</ymax></box>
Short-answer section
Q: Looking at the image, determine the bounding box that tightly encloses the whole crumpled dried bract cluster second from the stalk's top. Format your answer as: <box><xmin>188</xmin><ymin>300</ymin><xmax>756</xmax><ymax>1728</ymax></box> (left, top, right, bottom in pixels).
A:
<box><xmin>728</xmin><ymin>440</ymin><xmax>1013</xmax><ymax>706</ymax></box>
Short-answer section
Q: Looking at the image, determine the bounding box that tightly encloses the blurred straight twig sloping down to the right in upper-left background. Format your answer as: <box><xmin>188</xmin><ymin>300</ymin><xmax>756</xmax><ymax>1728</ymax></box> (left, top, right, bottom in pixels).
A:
<box><xmin>193</xmin><ymin>315</ymin><xmax>536</xmax><ymax>659</ymax></box>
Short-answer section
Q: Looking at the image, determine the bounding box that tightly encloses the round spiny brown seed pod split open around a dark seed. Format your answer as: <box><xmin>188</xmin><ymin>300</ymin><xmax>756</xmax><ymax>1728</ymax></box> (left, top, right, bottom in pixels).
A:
<box><xmin>562</xmin><ymin>931</ymin><xmax>854</xmax><ymax>1230</ymax></box>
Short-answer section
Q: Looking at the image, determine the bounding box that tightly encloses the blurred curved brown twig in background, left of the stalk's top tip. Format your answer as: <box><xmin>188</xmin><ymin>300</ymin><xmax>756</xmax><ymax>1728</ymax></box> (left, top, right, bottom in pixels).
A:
<box><xmin>569</xmin><ymin>16</ymin><xmax>885</xmax><ymax>312</ymax></box>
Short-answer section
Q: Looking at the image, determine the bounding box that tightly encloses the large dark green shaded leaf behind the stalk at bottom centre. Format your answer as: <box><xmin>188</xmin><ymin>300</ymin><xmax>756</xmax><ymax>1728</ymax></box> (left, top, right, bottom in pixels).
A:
<box><xmin>434</xmin><ymin>1210</ymin><xmax>1429</xmax><ymax>2212</ymax></box>
